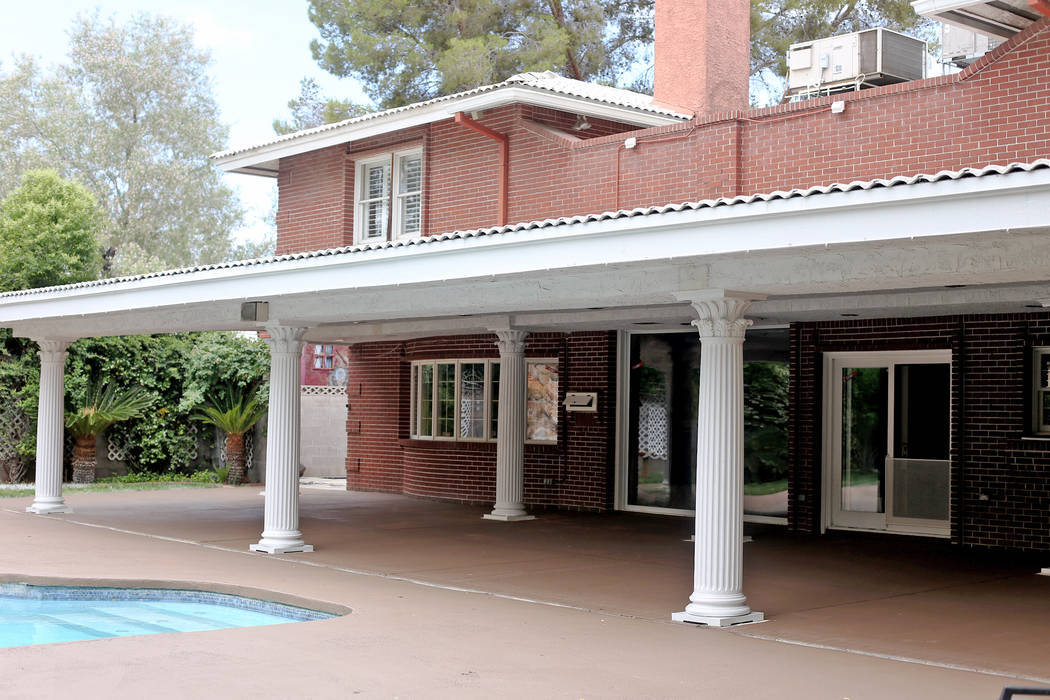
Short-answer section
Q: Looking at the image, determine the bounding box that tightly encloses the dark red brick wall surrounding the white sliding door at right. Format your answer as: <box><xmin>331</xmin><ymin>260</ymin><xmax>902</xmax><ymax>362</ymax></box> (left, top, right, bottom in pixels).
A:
<box><xmin>789</xmin><ymin>313</ymin><xmax>1050</xmax><ymax>551</ymax></box>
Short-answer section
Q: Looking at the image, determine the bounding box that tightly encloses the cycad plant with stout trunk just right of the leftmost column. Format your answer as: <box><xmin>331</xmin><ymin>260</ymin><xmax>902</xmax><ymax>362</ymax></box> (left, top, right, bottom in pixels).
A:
<box><xmin>66</xmin><ymin>380</ymin><xmax>150</xmax><ymax>484</ymax></box>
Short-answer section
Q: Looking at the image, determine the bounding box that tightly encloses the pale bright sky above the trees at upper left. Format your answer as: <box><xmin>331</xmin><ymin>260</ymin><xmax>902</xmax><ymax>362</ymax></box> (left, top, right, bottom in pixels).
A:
<box><xmin>0</xmin><ymin>0</ymin><xmax>364</xmax><ymax>246</ymax></box>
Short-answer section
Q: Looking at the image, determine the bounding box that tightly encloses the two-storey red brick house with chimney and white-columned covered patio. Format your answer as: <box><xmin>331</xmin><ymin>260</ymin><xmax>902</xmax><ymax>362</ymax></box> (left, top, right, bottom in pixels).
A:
<box><xmin>0</xmin><ymin>0</ymin><xmax>1050</xmax><ymax>624</ymax></box>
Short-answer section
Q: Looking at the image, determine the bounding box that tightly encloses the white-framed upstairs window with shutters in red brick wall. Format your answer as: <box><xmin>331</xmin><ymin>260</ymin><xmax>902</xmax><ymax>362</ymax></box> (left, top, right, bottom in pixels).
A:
<box><xmin>354</xmin><ymin>148</ymin><xmax>423</xmax><ymax>243</ymax></box>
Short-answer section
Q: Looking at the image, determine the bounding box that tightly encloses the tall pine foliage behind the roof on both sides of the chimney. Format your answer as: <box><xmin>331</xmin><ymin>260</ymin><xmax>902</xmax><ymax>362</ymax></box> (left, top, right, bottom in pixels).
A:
<box><xmin>298</xmin><ymin>0</ymin><xmax>931</xmax><ymax>119</ymax></box>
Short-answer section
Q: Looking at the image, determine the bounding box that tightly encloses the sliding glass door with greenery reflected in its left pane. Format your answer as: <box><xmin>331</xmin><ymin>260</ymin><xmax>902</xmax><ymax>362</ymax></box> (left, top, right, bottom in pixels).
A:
<box><xmin>824</xmin><ymin>351</ymin><xmax>951</xmax><ymax>534</ymax></box>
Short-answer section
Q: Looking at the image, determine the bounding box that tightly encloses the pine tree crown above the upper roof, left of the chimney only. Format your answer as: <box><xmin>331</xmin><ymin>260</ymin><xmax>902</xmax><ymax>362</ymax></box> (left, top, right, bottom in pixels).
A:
<box><xmin>300</xmin><ymin>0</ymin><xmax>653</xmax><ymax>108</ymax></box>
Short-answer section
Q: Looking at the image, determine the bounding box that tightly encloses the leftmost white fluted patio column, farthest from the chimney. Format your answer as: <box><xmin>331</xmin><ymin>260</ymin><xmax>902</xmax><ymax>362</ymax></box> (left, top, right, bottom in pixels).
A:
<box><xmin>25</xmin><ymin>339</ymin><xmax>72</xmax><ymax>515</ymax></box>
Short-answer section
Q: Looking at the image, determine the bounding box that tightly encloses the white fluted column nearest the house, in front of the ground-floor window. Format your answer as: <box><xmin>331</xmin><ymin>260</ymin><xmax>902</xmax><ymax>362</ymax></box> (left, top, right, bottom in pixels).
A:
<box><xmin>483</xmin><ymin>331</ymin><xmax>533</xmax><ymax>521</ymax></box>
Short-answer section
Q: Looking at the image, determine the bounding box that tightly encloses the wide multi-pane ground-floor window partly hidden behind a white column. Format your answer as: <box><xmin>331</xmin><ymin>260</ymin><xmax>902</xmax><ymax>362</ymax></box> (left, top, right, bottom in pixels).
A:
<box><xmin>410</xmin><ymin>359</ymin><xmax>560</xmax><ymax>443</ymax></box>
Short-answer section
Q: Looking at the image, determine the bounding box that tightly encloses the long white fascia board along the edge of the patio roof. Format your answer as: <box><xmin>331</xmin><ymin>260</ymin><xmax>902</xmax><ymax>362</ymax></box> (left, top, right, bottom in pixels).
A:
<box><xmin>0</xmin><ymin>170</ymin><xmax>1050</xmax><ymax>326</ymax></box>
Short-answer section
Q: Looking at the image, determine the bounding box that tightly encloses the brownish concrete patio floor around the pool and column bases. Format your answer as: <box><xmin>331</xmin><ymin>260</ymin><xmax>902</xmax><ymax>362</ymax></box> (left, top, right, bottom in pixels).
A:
<box><xmin>0</xmin><ymin>487</ymin><xmax>1050</xmax><ymax>700</ymax></box>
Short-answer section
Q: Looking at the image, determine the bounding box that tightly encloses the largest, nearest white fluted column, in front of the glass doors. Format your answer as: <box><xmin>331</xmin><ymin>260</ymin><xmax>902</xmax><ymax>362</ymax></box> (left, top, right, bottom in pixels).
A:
<box><xmin>671</xmin><ymin>296</ymin><xmax>762</xmax><ymax>627</ymax></box>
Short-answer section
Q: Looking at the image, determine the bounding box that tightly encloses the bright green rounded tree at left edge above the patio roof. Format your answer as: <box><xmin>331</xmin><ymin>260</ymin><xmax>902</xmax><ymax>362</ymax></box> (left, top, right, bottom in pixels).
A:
<box><xmin>0</xmin><ymin>170</ymin><xmax>103</xmax><ymax>292</ymax></box>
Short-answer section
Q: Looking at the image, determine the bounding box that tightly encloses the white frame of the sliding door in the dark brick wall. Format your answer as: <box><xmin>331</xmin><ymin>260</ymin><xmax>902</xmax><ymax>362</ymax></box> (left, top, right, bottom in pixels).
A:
<box><xmin>820</xmin><ymin>348</ymin><xmax>951</xmax><ymax>537</ymax></box>
